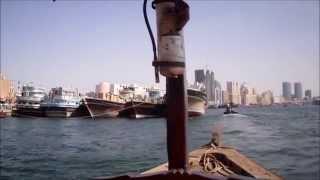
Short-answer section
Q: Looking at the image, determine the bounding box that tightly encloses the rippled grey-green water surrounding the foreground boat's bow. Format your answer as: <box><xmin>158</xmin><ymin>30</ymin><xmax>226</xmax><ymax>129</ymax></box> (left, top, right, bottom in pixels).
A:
<box><xmin>0</xmin><ymin>106</ymin><xmax>320</xmax><ymax>179</ymax></box>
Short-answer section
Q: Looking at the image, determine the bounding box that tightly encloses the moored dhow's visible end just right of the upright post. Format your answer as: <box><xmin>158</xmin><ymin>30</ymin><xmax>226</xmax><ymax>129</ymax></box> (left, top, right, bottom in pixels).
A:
<box><xmin>187</xmin><ymin>88</ymin><xmax>207</xmax><ymax>116</ymax></box>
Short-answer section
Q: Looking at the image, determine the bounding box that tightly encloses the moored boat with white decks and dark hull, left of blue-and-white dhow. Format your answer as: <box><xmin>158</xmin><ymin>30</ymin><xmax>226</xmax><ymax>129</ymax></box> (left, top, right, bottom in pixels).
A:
<box><xmin>14</xmin><ymin>85</ymin><xmax>46</xmax><ymax>117</ymax></box>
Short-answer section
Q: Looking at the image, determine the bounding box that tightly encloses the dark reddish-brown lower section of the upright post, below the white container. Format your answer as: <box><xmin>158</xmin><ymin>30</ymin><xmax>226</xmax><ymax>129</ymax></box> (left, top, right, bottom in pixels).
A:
<box><xmin>166</xmin><ymin>75</ymin><xmax>188</xmax><ymax>170</ymax></box>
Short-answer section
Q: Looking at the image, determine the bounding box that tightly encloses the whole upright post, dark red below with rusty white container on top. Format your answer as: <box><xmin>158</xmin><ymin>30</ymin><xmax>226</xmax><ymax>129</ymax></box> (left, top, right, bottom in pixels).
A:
<box><xmin>153</xmin><ymin>0</ymin><xmax>189</xmax><ymax>170</ymax></box>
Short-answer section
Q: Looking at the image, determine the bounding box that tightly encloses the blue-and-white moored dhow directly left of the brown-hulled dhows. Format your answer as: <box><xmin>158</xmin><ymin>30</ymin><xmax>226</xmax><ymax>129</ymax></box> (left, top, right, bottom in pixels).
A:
<box><xmin>41</xmin><ymin>87</ymin><xmax>81</xmax><ymax>117</ymax></box>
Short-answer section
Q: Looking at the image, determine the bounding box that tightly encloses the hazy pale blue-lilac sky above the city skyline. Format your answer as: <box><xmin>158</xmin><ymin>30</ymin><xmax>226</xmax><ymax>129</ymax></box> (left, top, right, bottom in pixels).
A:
<box><xmin>1</xmin><ymin>0</ymin><xmax>319</xmax><ymax>95</ymax></box>
